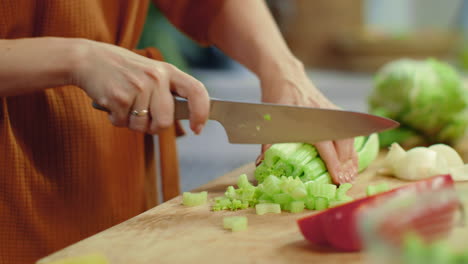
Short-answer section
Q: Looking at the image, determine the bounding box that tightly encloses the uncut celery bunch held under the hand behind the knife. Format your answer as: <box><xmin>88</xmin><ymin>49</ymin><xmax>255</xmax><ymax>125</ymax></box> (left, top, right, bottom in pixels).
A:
<box><xmin>255</xmin><ymin>134</ymin><xmax>379</xmax><ymax>183</ymax></box>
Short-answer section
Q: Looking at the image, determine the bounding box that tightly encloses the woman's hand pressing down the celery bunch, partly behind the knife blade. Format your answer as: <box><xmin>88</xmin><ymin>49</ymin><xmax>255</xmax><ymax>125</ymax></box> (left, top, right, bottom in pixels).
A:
<box><xmin>257</xmin><ymin>62</ymin><xmax>358</xmax><ymax>184</ymax></box>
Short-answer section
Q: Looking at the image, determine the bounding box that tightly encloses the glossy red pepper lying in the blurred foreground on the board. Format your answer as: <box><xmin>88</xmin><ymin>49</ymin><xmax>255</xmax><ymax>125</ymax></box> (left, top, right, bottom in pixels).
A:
<box><xmin>297</xmin><ymin>175</ymin><xmax>458</xmax><ymax>251</ymax></box>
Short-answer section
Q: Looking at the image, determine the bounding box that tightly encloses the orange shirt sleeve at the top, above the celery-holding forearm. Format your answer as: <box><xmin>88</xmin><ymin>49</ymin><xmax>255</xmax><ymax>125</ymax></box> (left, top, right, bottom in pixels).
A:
<box><xmin>153</xmin><ymin>0</ymin><xmax>225</xmax><ymax>45</ymax></box>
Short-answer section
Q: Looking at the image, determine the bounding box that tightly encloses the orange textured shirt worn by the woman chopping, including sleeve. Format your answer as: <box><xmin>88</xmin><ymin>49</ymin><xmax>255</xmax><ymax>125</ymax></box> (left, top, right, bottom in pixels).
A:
<box><xmin>0</xmin><ymin>0</ymin><xmax>227</xmax><ymax>264</ymax></box>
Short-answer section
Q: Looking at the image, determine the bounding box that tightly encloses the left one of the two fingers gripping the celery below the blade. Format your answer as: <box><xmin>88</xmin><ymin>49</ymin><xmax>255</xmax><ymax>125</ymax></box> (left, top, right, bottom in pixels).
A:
<box><xmin>315</xmin><ymin>141</ymin><xmax>346</xmax><ymax>183</ymax></box>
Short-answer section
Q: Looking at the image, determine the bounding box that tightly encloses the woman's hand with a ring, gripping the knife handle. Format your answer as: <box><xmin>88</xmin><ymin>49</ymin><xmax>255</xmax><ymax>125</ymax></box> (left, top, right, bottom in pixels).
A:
<box><xmin>71</xmin><ymin>39</ymin><xmax>209</xmax><ymax>134</ymax></box>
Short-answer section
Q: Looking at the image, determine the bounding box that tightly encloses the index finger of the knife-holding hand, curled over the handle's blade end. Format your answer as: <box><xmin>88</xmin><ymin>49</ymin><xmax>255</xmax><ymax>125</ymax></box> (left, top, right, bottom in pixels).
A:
<box><xmin>165</xmin><ymin>67</ymin><xmax>210</xmax><ymax>134</ymax></box>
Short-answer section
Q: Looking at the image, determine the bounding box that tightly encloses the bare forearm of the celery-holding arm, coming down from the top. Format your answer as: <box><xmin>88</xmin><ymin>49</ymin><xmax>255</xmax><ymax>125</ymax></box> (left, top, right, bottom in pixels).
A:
<box><xmin>209</xmin><ymin>0</ymin><xmax>303</xmax><ymax>84</ymax></box>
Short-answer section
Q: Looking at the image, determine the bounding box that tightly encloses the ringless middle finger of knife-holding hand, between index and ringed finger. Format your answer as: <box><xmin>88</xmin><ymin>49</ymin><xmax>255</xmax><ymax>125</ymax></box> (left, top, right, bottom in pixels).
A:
<box><xmin>149</xmin><ymin>73</ymin><xmax>174</xmax><ymax>134</ymax></box>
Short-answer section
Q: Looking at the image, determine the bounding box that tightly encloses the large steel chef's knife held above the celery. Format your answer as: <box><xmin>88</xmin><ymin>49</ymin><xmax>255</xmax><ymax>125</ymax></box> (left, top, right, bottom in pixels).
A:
<box><xmin>93</xmin><ymin>96</ymin><xmax>399</xmax><ymax>144</ymax></box>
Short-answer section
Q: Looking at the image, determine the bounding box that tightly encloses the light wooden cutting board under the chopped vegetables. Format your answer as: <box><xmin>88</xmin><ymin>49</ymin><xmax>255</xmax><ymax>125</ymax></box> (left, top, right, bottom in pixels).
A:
<box><xmin>39</xmin><ymin>144</ymin><xmax>468</xmax><ymax>264</ymax></box>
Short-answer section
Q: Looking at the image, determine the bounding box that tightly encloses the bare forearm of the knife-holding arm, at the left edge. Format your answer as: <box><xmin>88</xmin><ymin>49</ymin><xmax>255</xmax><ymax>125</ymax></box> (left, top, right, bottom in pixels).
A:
<box><xmin>0</xmin><ymin>38</ymin><xmax>79</xmax><ymax>96</ymax></box>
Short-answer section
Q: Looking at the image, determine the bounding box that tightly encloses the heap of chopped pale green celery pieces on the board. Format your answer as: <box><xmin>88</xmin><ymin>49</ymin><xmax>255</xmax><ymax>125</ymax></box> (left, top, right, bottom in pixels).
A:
<box><xmin>212</xmin><ymin>174</ymin><xmax>352</xmax><ymax>214</ymax></box>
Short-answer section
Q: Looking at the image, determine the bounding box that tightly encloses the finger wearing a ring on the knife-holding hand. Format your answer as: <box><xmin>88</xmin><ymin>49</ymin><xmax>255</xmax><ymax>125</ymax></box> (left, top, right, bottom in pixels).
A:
<box><xmin>129</xmin><ymin>78</ymin><xmax>155</xmax><ymax>132</ymax></box>
